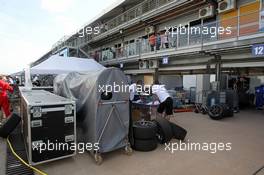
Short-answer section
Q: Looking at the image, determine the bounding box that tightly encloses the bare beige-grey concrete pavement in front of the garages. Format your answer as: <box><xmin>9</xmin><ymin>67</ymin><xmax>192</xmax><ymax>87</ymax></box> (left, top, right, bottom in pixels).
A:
<box><xmin>35</xmin><ymin>110</ymin><xmax>264</xmax><ymax>175</ymax></box>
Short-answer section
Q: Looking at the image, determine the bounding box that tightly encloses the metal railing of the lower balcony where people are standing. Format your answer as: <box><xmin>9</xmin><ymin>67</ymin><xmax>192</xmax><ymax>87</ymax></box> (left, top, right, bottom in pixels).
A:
<box><xmin>95</xmin><ymin>11</ymin><xmax>264</xmax><ymax>62</ymax></box>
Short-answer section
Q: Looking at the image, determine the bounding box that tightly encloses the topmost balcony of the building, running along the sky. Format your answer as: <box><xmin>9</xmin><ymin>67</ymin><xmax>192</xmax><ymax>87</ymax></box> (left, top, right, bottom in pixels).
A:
<box><xmin>52</xmin><ymin>0</ymin><xmax>192</xmax><ymax>52</ymax></box>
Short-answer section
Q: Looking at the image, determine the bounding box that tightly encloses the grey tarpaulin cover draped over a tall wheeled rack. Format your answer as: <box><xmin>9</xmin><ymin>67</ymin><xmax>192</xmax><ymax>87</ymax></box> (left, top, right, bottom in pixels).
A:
<box><xmin>54</xmin><ymin>68</ymin><xmax>129</xmax><ymax>153</ymax></box>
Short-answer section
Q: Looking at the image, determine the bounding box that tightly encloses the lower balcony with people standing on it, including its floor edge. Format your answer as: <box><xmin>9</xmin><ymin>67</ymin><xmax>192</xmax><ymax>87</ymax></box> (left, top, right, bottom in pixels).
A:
<box><xmin>91</xmin><ymin>11</ymin><xmax>264</xmax><ymax>65</ymax></box>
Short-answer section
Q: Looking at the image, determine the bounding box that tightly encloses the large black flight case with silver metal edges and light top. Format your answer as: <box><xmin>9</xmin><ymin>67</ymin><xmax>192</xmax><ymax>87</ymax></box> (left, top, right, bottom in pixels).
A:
<box><xmin>20</xmin><ymin>88</ymin><xmax>76</xmax><ymax>165</ymax></box>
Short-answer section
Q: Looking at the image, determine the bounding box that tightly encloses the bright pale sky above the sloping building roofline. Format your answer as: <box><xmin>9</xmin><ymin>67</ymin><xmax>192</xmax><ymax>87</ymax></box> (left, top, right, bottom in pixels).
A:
<box><xmin>0</xmin><ymin>0</ymin><xmax>118</xmax><ymax>74</ymax></box>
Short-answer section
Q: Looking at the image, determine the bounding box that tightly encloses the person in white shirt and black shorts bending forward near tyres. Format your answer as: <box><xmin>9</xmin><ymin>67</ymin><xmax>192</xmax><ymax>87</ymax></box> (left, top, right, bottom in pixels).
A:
<box><xmin>152</xmin><ymin>81</ymin><xmax>173</xmax><ymax>120</ymax></box>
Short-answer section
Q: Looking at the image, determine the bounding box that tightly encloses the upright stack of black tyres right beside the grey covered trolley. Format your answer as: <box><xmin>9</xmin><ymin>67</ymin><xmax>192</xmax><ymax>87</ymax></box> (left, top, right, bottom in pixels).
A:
<box><xmin>132</xmin><ymin>121</ymin><xmax>157</xmax><ymax>152</ymax></box>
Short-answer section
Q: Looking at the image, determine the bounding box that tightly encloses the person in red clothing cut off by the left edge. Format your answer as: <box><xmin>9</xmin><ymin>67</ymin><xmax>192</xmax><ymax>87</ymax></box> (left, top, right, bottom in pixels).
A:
<box><xmin>0</xmin><ymin>76</ymin><xmax>14</xmax><ymax>118</ymax></box>
